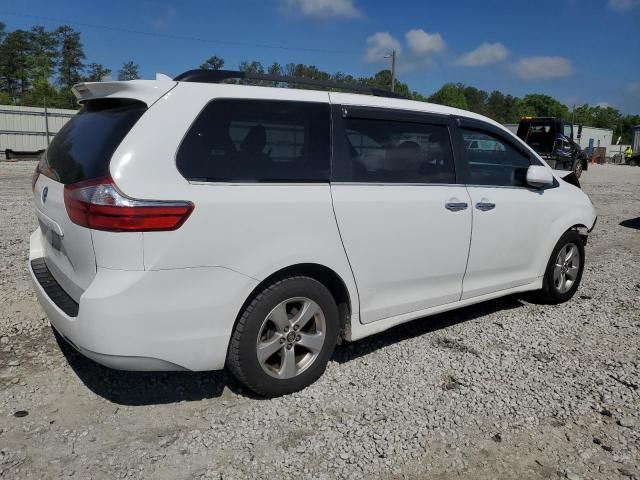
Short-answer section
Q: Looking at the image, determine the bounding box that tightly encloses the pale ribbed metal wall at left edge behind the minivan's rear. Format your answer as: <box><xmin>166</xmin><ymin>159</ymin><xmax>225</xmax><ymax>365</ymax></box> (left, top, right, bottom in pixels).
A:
<box><xmin>0</xmin><ymin>105</ymin><xmax>77</xmax><ymax>158</ymax></box>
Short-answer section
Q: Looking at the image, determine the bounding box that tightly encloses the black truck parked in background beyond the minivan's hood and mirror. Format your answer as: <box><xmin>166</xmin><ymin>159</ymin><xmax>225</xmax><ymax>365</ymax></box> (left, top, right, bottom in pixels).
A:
<box><xmin>517</xmin><ymin>117</ymin><xmax>589</xmax><ymax>178</ymax></box>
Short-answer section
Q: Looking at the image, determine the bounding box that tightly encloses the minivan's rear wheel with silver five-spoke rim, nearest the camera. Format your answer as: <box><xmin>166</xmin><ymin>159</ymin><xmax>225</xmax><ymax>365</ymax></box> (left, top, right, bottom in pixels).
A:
<box><xmin>227</xmin><ymin>276</ymin><xmax>339</xmax><ymax>397</ymax></box>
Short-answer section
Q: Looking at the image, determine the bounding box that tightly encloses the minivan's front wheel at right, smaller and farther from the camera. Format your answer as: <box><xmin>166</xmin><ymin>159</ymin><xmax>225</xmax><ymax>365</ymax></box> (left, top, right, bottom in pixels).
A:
<box><xmin>539</xmin><ymin>230</ymin><xmax>585</xmax><ymax>304</ymax></box>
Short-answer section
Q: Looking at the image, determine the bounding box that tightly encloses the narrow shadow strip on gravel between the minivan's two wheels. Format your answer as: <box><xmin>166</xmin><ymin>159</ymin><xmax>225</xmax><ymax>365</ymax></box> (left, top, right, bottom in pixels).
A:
<box><xmin>333</xmin><ymin>294</ymin><xmax>529</xmax><ymax>363</ymax></box>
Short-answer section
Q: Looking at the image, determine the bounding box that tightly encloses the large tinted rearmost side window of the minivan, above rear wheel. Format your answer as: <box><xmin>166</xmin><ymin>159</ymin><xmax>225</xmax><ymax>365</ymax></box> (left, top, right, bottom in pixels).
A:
<box><xmin>177</xmin><ymin>99</ymin><xmax>330</xmax><ymax>182</ymax></box>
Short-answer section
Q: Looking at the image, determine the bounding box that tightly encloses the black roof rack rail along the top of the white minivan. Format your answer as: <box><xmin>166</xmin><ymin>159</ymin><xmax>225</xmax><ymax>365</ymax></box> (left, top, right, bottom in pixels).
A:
<box><xmin>174</xmin><ymin>69</ymin><xmax>405</xmax><ymax>98</ymax></box>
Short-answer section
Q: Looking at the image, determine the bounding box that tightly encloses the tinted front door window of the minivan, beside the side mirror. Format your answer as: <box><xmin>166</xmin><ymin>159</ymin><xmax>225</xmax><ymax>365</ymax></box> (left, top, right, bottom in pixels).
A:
<box><xmin>462</xmin><ymin>128</ymin><xmax>530</xmax><ymax>186</ymax></box>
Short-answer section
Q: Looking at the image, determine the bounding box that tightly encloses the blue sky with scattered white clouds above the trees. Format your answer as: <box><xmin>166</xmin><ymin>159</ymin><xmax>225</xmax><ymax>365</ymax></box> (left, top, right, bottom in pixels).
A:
<box><xmin>0</xmin><ymin>0</ymin><xmax>640</xmax><ymax>114</ymax></box>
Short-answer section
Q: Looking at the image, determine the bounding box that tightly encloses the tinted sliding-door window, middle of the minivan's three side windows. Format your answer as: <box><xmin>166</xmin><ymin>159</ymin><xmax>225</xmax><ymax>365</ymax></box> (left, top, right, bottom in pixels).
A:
<box><xmin>338</xmin><ymin>118</ymin><xmax>455</xmax><ymax>183</ymax></box>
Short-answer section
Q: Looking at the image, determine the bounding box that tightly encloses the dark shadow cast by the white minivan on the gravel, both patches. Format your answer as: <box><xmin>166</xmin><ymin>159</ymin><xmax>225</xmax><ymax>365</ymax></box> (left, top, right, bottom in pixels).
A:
<box><xmin>52</xmin><ymin>296</ymin><xmax>523</xmax><ymax>406</ymax></box>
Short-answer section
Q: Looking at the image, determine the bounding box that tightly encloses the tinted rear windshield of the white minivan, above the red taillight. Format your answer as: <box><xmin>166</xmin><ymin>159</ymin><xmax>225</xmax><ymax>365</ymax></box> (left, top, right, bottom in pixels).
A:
<box><xmin>39</xmin><ymin>99</ymin><xmax>147</xmax><ymax>184</ymax></box>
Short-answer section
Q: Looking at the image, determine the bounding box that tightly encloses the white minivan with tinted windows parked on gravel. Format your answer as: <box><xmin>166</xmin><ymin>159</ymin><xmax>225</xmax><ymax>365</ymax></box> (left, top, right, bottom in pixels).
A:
<box><xmin>29</xmin><ymin>71</ymin><xmax>596</xmax><ymax>396</ymax></box>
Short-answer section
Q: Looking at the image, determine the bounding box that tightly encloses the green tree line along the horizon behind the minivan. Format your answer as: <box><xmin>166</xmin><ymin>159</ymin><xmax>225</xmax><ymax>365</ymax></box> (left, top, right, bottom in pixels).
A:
<box><xmin>0</xmin><ymin>22</ymin><xmax>640</xmax><ymax>143</ymax></box>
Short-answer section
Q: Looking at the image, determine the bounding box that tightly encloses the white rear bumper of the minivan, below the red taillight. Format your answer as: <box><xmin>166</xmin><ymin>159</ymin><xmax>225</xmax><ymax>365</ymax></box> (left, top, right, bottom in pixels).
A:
<box><xmin>29</xmin><ymin>231</ymin><xmax>257</xmax><ymax>371</ymax></box>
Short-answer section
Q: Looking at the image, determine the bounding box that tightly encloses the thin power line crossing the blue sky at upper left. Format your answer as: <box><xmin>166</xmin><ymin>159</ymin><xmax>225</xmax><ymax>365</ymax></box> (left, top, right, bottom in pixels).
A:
<box><xmin>2</xmin><ymin>11</ymin><xmax>365</xmax><ymax>55</ymax></box>
